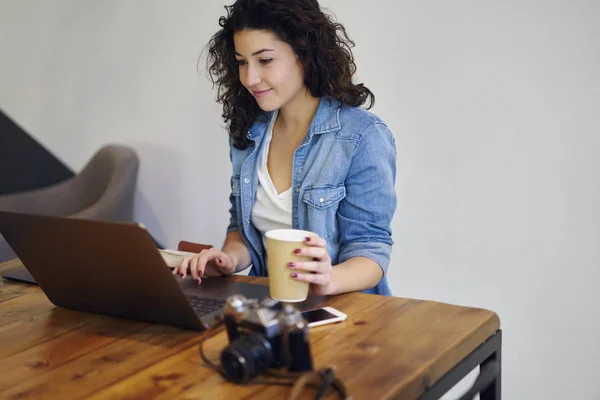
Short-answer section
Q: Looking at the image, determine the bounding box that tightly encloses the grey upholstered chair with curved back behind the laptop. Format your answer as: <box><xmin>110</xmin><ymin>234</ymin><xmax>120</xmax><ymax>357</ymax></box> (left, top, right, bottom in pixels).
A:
<box><xmin>0</xmin><ymin>145</ymin><xmax>139</xmax><ymax>262</ymax></box>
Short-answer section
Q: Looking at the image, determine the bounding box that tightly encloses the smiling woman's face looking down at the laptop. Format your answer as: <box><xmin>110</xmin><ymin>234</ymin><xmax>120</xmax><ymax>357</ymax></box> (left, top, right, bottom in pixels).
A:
<box><xmin>233</xmin><ymin>29</ymin><xmax>306</xmax><ymax>111</ymax></box>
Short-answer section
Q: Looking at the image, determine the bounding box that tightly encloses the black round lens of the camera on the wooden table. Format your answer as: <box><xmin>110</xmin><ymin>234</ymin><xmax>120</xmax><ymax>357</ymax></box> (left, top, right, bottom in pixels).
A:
<box><xmin>221</xmin><ymin>332</ymin><xmax>273</xmax><ymax>383</ymax></box>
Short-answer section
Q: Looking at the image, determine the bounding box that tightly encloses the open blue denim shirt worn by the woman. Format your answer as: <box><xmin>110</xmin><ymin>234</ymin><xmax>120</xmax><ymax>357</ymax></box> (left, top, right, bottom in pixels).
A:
<box><xmin>227</xmin><ymin>97</ymin><xmax>396</xmax><ymax>295</ymax></box>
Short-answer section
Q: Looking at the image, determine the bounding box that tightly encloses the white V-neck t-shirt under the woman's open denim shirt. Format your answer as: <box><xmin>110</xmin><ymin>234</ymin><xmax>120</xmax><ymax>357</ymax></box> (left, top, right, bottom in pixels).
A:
<box><xmin>251</xmin><ymin>111</ymin><xmax>292</xmax><ymax>248</ymax></box>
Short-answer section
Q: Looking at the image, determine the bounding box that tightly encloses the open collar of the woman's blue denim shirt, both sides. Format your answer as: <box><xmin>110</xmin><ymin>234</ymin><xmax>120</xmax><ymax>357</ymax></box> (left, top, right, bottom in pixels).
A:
<box><xmin>247</xmin><ymin>97</ymin><xmax>341</xmax><ymax>142</ymax></box>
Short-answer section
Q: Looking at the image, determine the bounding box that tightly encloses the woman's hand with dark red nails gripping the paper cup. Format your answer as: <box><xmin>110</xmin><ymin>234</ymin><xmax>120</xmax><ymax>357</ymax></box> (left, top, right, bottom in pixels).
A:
<box><xmin>289</xmin><ymin>234</ymin><xmax>333</xmax><ymax>296</ymax></box>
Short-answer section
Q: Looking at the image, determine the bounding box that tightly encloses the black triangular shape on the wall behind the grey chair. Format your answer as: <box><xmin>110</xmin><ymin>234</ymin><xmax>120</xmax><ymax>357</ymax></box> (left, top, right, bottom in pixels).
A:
<box><xmin>0</xmin><ymin>110</ymin><xmax>74</xmax><ymax>195</ymax></box>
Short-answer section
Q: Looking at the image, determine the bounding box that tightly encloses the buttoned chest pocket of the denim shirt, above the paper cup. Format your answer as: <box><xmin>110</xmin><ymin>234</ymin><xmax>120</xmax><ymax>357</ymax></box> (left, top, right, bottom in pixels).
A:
<box><xmin>302</xmin><ymin>184</ymin><xmax>346</xmax><ymax>239</ymax></box>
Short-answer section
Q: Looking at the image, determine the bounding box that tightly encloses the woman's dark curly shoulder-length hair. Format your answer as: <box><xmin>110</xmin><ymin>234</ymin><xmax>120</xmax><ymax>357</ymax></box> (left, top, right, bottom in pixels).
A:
<box><xmin>207</xmin><ymin>0</ymin><xmax>375</xmax><ymax>149</ymax></box>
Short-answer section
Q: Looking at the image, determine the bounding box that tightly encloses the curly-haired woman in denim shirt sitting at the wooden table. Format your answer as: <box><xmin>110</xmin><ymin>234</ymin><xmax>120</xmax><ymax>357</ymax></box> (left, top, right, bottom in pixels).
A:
<box><xmin>173</xmin><ymin>0</ymin><xmax>396</xmax><ymax>295</ymax></box>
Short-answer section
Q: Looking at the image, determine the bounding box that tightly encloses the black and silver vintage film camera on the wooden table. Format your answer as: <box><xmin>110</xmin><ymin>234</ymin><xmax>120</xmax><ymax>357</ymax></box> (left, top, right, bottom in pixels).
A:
<box><xmin>221</xmin><ymin>295</ymin><xmax>313</xmax><ymax>383</ymax></box>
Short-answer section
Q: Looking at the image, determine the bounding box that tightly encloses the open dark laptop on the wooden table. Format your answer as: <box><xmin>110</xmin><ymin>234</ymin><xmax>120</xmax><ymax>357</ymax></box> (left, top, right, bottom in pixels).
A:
<box><xmin>0</xmin><ymin>211</ymin><xmax>322</xmax><ymax>330</ymax></box>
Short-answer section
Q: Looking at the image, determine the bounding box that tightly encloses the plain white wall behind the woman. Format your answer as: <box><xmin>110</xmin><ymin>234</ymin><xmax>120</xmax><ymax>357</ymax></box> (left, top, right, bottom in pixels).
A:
<box><xmin>0</xmin><ymin>0</ymin><xmax>600</xmax><ymax>400</ymax></box>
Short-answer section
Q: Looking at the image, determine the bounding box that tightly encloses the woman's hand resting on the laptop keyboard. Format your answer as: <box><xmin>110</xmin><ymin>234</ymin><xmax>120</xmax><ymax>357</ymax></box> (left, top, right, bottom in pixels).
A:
<box><xmin>173</xmin><ymin>247</ymin><xmax>237</xmax><ymax>285</ymax></box>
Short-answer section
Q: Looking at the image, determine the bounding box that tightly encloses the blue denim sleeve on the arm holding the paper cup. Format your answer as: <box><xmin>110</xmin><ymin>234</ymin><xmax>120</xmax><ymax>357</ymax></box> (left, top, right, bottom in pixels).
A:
<box><xmin>338</xmin><ymin>122</ymin><xmax>396</xmax><ymax>276</ymax></box>
